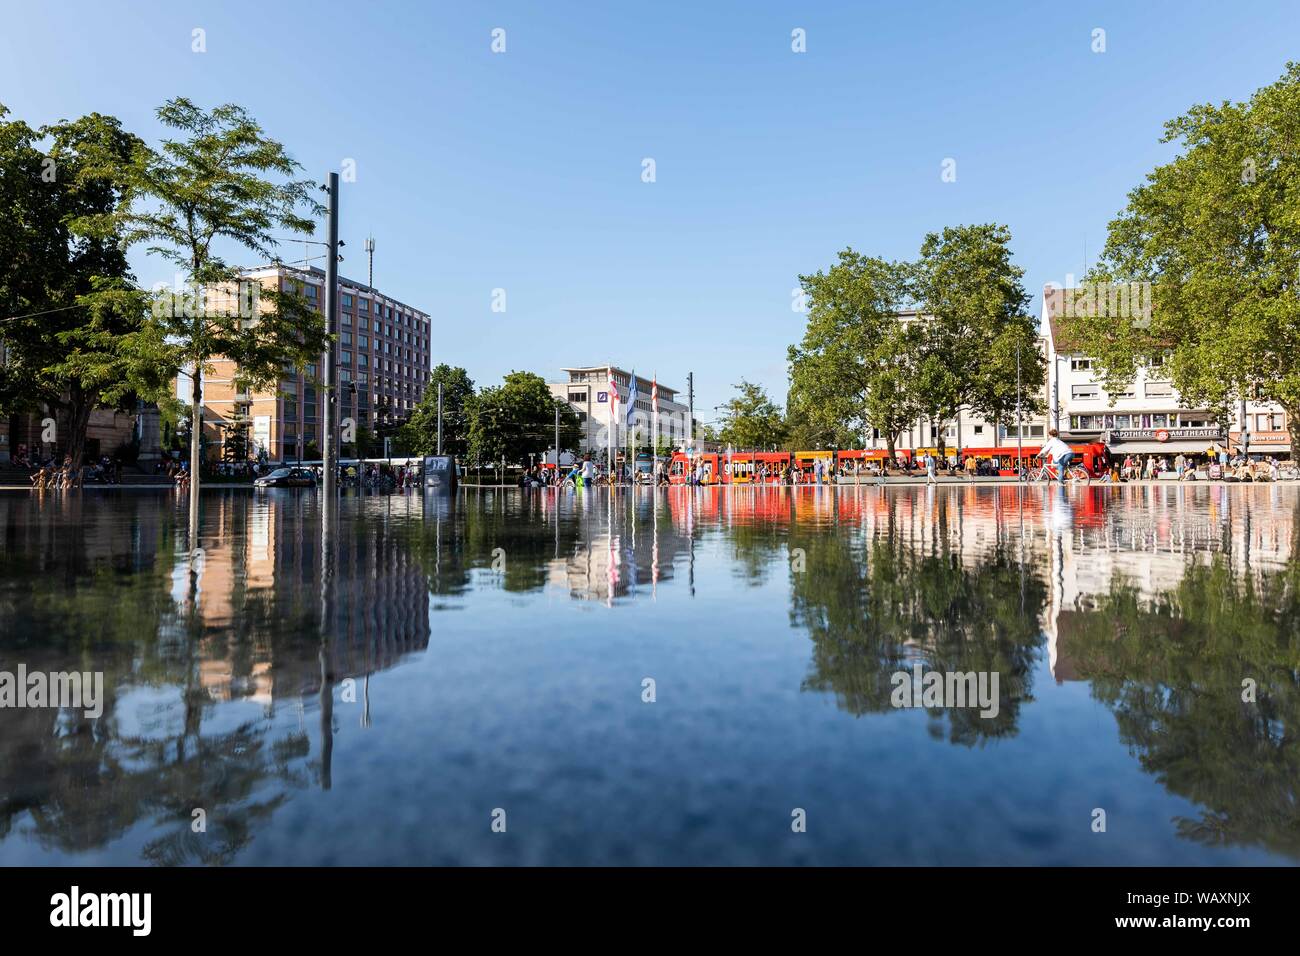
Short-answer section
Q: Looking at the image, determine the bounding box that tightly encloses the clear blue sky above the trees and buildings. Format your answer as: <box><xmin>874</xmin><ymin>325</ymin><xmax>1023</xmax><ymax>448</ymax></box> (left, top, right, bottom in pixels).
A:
<box><xmin>0</xmin><ymin>0</ymin><xmax>1300</xmax><ymax>420</ymax></box>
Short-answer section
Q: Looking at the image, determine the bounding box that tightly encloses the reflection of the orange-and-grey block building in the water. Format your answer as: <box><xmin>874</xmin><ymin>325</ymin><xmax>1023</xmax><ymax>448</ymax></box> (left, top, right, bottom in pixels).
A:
<box><xmin>183</xmin><ymin>496</ymin><xmax>429</xmax><ymax>704</ymax></box>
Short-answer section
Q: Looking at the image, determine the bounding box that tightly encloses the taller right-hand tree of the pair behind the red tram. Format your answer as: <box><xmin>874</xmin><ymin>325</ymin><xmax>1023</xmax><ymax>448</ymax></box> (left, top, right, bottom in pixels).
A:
<box><xmin>911</xmin><ymin>222</ymin><xmax>1045</xmax><ymax>455</ymax></box>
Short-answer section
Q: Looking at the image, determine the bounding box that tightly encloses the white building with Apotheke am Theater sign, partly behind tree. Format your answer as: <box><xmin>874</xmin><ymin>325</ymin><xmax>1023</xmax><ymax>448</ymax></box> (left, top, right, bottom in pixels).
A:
<box><xmin>1041</xmin><ymin>289</ymin><xmax>1291</xmax><ymax>457</ymax></box>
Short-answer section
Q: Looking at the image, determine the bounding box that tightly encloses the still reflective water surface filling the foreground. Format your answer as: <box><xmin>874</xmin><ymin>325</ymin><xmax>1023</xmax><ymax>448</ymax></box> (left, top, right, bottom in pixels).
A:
<box><xmin>0</xmin><ymin>485</ymin><xmax>1300</xmax><ymax>865</ymax></box>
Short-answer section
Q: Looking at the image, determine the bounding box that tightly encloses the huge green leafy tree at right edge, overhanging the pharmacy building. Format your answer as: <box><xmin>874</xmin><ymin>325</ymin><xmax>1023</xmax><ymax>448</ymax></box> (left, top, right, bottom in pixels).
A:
<box><xmin>1069</xmin><ymin>62</ymin><xmax>1300</xmax><ymax>447</ymax></box>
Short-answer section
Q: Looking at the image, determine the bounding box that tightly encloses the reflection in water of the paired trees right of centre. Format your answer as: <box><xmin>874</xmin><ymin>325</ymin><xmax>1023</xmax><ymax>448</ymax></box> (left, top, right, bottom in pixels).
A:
<box><xmin>790</xmin><ymin>529</ymin><xmax>1047</xmax><ymax>747</ymax></box>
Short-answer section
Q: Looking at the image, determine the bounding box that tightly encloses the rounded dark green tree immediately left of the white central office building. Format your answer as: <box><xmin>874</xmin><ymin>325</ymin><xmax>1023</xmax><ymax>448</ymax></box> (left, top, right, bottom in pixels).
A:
<box><xmin>465</xmin><ymin>372</ymin><xmax>581</xmax><ymax>464</ymax></box>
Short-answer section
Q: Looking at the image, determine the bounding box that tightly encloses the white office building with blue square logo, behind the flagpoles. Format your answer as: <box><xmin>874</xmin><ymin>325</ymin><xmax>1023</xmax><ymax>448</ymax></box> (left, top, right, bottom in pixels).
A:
<box><xmin>550</xmin><ymin>364</ymin><xmax>698</xmax><ymax>451</ymax></box>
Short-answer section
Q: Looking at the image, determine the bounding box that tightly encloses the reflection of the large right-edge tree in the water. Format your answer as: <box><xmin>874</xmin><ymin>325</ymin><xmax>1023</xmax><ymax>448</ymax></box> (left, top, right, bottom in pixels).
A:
<box><xmin>1061</xmin><ymin>557</ymin><xmax>1300</xmax><ymax>857</ymax></box>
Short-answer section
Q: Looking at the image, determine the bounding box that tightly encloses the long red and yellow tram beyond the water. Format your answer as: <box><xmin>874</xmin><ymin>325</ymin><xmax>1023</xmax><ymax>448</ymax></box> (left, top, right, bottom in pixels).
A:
<box><xmin>668</xmin><ymin>442</ymin><xmax>1110</xmax><ymax>485</ymax></box>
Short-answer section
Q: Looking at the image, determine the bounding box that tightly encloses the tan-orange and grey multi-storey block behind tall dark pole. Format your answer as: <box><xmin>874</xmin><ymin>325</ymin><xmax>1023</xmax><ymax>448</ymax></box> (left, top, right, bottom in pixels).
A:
<box><xmin>193</xmin><ymin>264</ymin><xmax>432</xmax><ymax>462</ymax></box>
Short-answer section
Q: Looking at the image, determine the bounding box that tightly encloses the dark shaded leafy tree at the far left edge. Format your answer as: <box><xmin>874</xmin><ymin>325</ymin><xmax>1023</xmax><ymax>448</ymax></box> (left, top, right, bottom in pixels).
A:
<box><xmin>0</xmin><ymin>105</ymin><xmax>166</xmax><ymax>463</ymax></box>
